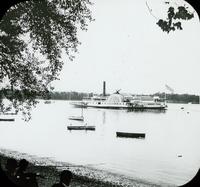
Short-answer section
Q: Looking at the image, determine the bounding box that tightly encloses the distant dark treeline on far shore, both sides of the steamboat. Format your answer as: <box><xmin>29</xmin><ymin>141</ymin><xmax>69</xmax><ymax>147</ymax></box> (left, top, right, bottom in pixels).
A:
<box><xmin>49</xmin><ymin>92</ymin><xmax>199</xmax><ymax>103</ymax></box>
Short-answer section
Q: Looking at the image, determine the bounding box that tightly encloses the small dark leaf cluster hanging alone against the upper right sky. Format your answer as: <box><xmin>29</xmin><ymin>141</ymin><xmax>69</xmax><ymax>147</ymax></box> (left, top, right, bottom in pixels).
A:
<box><xmin>157</xmin><ymin>6</ymin><xmax>194</xmax><ymax>33</ymax></box>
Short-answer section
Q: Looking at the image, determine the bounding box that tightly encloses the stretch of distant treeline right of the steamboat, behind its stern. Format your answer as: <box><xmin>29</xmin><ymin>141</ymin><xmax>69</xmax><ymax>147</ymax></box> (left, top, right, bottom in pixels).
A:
<box><xmin>153</xmin><ymin>93</ymin><xmax>199</xmax><ymax>104</ymax></box>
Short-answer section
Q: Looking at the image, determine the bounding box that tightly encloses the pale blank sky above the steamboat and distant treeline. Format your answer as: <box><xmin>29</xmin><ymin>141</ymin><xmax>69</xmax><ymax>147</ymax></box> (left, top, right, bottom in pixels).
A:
<box><xmin>52</xmin><ymin>0</ymin><xmax>200</xmax><ymax>95</ymax></box>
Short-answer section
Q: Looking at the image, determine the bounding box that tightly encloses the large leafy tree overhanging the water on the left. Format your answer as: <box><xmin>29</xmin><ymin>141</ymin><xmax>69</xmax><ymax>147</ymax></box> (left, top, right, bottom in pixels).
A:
<box><xmin>0</xmin><ymin>0</ymin><xmax>92</xmax><ymax>119</ymax></box>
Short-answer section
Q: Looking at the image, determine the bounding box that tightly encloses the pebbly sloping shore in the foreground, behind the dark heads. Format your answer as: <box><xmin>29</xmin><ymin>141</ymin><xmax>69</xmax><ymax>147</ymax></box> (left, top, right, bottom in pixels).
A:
<box><xmin>0</xmin><ymin>149</ymin><xmax>169</xmax><ymax>187</ymax></box>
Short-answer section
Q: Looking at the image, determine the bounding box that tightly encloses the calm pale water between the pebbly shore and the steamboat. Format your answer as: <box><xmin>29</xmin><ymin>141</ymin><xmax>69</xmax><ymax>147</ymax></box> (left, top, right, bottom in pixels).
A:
<box><xmin>0</xmin><ymin>101</ymin><xmax>200</xmax><ymax>185</ymax></box>
